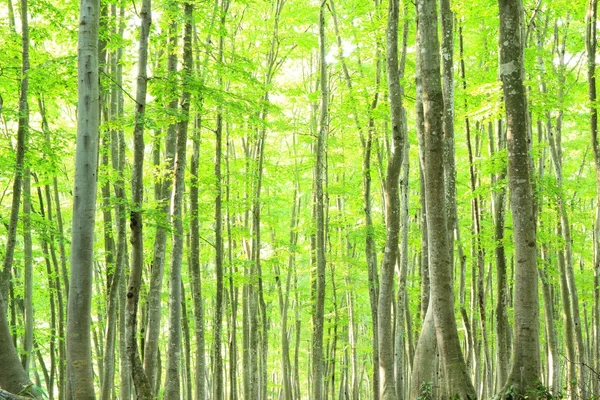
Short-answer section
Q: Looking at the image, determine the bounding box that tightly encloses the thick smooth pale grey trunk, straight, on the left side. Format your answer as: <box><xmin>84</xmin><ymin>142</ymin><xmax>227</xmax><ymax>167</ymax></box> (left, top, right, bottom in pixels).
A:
<box><xmin>67</xmin><ymin>0</ymin><xmax>100</xmax><ymax>399</ymax></box>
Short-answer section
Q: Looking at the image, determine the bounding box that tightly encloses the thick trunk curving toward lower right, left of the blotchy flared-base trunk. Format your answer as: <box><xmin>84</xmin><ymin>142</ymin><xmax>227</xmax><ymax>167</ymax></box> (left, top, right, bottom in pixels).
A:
<box><xmin>417</xmin><ymin>0</ymin><xmax>476</xmax><ymax>399</ymax></box>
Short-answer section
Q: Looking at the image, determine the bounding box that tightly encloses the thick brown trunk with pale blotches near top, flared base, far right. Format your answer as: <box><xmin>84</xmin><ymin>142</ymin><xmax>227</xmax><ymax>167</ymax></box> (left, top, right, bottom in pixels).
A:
<box><xmin>499</xmin><ymin>0</ymin><xmax>540</xmax><ymax>396</ymax></box>
